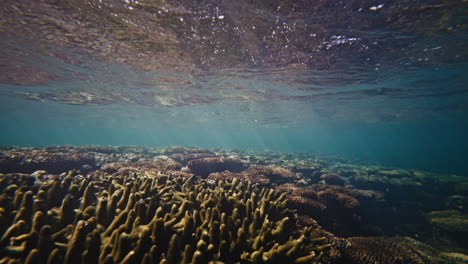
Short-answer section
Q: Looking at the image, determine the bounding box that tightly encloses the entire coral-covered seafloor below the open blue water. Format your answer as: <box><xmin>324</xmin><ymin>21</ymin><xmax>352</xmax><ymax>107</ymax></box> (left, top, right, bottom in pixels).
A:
<box><xmin>0</xmin><ymin>146</ymin><xmax>468</xmax><ymax>264</ymax></box>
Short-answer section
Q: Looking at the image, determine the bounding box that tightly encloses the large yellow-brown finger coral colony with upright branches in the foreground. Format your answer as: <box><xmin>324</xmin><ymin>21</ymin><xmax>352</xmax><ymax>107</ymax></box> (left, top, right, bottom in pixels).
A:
<box><xmin>0</xmin><ymin>172</ymin><xmax>333</xmax><ymax>264</ymax></box>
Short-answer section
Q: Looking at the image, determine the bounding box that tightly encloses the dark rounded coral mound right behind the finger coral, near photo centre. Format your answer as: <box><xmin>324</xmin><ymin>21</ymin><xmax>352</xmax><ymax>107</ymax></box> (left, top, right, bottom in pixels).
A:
<box><xmin>187</xmin><ymin>157</ymin><xmax>247</xmax><ymax>177</ymax></box>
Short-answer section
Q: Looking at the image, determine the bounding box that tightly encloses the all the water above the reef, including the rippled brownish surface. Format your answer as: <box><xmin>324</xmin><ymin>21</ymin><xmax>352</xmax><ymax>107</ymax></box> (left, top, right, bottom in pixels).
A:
<box><xmin>0</xmin><ymin>0</ymin><xmax>468</xmax><ymax>175</ymax></box>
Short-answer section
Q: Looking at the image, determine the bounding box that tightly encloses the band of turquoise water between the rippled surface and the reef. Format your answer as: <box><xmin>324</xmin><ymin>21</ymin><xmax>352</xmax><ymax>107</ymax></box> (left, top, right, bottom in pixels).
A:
<box><xmin>0</xmin><ymin>94</ymin><xmax>468</xmax><ymax>175</ymax></box>
